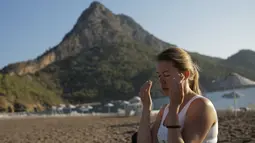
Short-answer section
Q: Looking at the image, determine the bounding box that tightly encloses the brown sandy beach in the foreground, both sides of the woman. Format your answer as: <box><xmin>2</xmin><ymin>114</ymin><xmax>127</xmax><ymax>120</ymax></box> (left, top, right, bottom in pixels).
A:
<box><xmin>0</xmin><ymin>112</ymin><xmax>255</xmax><ymax>143</ymax></box>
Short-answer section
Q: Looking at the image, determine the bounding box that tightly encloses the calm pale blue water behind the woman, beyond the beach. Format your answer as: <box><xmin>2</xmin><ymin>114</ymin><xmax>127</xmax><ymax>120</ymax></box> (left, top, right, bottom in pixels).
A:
<box><xmin>153</xmin><ymin>87</ymin><xmax>255</xmax><ymax>110</ymax></box>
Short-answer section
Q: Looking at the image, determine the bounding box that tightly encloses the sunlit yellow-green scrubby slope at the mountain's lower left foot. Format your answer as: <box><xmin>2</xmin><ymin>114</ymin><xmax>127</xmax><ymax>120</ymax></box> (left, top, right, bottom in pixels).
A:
<box><xmin>0</xmin><ymin>74</ymin><xmax>62</xmax><ymax>111</ymax></box>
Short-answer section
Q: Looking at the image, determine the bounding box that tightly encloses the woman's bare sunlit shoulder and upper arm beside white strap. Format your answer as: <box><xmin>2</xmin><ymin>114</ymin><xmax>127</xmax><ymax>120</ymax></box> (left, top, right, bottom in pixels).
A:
<box><xmin>182</xmin><ymin>98</ymin><xmax>217</xmax><ymax>143</ymax></box>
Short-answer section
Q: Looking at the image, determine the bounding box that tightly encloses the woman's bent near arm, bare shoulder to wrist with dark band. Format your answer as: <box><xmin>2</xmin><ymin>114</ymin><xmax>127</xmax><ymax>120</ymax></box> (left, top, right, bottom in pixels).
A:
<box><xmin>167</xmin><ymin>98</ymin><xmax>216</xmax><ymax>143</ymax></box>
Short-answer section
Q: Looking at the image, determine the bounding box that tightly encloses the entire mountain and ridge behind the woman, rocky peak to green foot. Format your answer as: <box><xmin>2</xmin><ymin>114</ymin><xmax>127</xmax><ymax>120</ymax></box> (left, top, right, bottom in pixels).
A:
<box><xmin>0</xmin><ymin>2</ymin><xmax>255</xmax><ymax>111</ymax></box>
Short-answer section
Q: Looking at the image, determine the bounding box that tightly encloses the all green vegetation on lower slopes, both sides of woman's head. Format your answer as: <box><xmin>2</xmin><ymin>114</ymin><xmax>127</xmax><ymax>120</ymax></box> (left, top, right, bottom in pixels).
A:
<box><xmin>0</xmin><ymin>41</ymin><xmax>255</xmax><ymax>111</ymax></box>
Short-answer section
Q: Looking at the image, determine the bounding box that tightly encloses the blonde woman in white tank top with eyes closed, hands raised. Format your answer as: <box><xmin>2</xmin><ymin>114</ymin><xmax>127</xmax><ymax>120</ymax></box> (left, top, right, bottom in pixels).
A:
<box><xmin>137</xmin><ymin>48</ymin><xmax>218</xmax><ymax>143</ymax></box>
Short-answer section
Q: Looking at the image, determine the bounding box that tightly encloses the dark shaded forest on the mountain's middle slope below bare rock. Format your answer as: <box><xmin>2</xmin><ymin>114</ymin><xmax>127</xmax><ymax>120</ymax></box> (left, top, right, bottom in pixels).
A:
<box><xmin>38</xmin><ymin>41</ymin><xmax>158</xmax><ymax>102</ymax></box>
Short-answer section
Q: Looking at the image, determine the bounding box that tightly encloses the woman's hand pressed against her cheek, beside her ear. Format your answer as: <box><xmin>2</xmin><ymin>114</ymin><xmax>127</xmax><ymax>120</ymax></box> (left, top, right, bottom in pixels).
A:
<box><xmin>167</xmin><ymin>74</ymin><xmax>184</xmax><ymax>106</ymax></box>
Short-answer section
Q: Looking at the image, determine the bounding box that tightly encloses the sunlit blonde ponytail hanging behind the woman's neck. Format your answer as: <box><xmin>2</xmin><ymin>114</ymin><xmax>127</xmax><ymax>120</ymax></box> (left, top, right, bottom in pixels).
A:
<box><xmin>190</xmin><ymin>64</ymin><xmax>201</xmax><ymax>95</ymax></box>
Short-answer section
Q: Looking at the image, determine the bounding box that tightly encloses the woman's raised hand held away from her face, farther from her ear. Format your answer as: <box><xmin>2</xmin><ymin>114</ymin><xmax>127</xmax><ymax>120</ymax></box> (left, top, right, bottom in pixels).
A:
<box><xmin>139</xmin><ymin>81</ymin><xmax>152</xmax><ymax>111</ymax></box>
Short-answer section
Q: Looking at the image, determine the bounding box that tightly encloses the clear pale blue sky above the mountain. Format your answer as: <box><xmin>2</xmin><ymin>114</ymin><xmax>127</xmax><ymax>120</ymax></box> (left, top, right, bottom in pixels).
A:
<box><xmin>0</xmin><ymin>0</ymin><xmax>255</xmax><ymax>68</ymax></box>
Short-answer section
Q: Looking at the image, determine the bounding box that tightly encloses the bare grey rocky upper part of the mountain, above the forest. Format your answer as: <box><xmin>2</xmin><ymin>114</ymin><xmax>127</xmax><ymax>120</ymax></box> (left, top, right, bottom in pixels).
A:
<box><xmin>2</xmin><ymin>1</ymin><xmax>174</xmax><ymax>75</ymax></box>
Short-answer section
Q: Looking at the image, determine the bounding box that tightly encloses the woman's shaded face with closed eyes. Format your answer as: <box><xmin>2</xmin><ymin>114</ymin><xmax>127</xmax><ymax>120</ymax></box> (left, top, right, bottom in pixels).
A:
<box><xmin>156</xmin><ymin>61</ymin><xmax>180</xmax><ymax>96</ymax></box>
